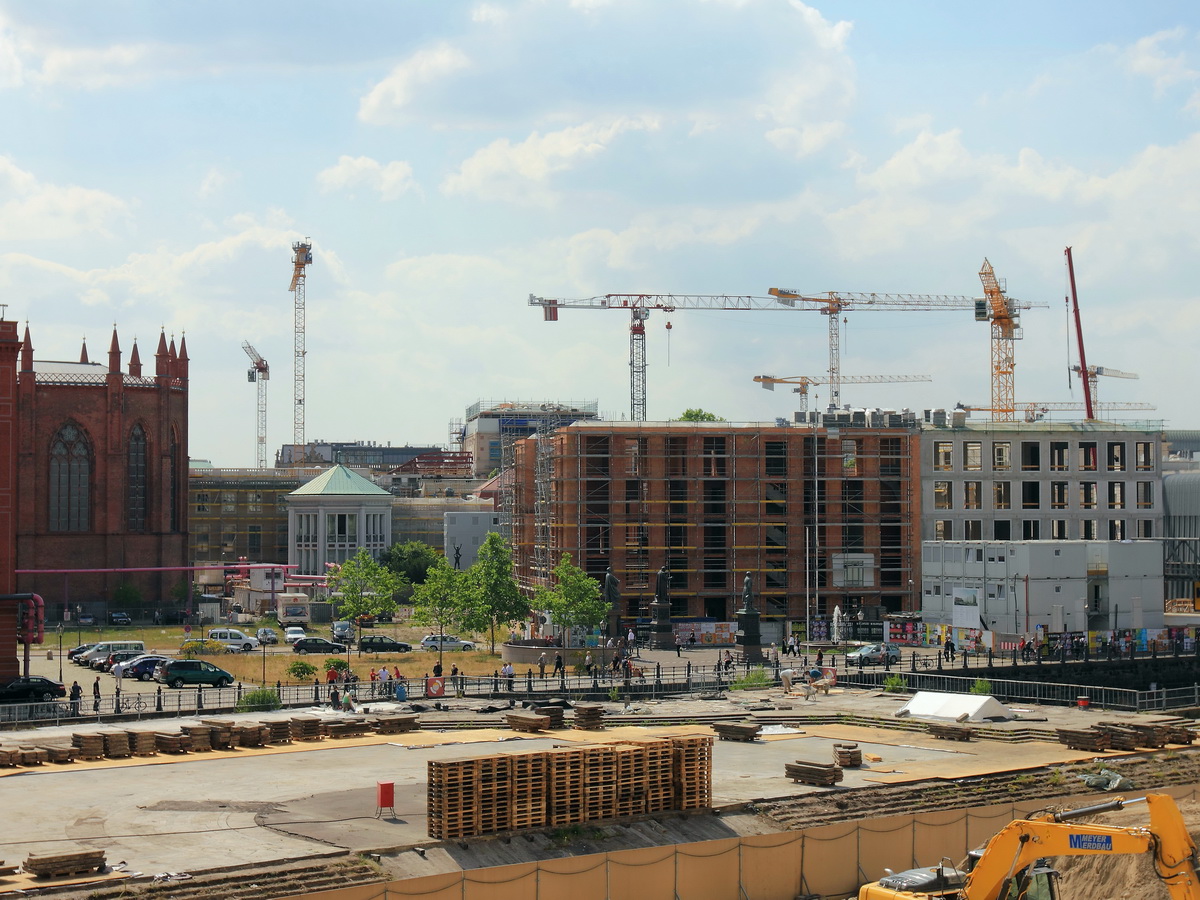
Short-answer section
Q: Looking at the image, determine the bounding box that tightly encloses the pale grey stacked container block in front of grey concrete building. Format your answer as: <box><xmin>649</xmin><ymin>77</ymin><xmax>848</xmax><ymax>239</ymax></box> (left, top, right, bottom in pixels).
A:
<box><xmin>922</xmin><ymin>540</ymin><xmax>1163</xmax><ymax>646</ymax></box>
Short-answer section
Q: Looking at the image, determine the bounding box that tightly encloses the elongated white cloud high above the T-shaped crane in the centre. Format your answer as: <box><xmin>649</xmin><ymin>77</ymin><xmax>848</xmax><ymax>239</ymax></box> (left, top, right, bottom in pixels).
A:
<box><xmin>442</xmin><ymin>116</ymin><xmax>659</xmax><ymax>204</ymax></box>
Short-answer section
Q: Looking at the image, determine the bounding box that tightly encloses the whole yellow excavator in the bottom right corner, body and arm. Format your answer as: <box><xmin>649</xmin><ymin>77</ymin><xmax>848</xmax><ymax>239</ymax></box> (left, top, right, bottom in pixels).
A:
<box><xmin>858</xmin><ymin>793</ymin><xmax>1200</xmax><ymax>900</ymax></box>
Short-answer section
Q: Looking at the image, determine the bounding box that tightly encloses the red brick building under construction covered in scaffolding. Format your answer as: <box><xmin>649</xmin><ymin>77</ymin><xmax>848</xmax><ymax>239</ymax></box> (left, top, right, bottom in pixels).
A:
<box><xmin>511</xmin><ymin>410</ymin><xmax>920</xmax><ymax>640</ymax></box>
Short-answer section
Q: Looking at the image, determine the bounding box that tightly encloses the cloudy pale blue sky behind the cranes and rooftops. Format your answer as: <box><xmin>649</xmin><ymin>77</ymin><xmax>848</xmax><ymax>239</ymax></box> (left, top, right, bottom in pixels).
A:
<box><xmin>0</xmin><ymin>0</ymin><xmax>1200</xmax><ymax>467</ymax></box>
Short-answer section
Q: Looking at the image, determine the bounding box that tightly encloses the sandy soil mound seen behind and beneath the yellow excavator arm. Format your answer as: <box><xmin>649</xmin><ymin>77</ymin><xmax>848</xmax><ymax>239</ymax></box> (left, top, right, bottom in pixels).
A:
<box><xmin>1055</xmin><ymin>800</ymin><xmax>1200</xmax><ymax>900</ymax></box>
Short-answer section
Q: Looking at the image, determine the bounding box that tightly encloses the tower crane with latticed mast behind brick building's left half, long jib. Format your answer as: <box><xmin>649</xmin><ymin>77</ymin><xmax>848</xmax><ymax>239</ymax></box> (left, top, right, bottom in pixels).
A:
<box><xmin>529</xmin><ymin>294</ymin><xmax>811</xmax><ymax>422</ymax></box>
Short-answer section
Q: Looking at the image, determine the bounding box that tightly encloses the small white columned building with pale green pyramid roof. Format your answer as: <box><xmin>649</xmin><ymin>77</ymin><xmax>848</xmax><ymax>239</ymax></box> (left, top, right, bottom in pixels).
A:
<box><xmin>287</xmin><ymin>466</ymin><xmax>392</xmax><ymax>575</ymax></box>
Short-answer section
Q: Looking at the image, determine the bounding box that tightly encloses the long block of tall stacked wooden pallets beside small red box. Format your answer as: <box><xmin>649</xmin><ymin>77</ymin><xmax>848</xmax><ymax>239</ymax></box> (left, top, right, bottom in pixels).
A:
<box><xmin>428</xmin><ymin>734</ymin><xmax>713</xmax><ymax>840</ymax></box>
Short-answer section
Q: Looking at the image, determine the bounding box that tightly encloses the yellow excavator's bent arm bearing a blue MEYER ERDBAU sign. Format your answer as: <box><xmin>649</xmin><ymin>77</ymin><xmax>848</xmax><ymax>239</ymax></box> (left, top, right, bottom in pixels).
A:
<box><xmin>962</xmin><ymin>794</ymin><xmax>1200</xmax><ymax>900</ymax></box>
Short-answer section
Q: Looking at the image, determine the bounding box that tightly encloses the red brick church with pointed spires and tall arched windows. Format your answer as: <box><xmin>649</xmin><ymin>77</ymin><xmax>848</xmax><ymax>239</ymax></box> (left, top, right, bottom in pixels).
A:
<box><xmin>0</xmin><ymin>320</ymin><xmax>187</xmax><ymax>677</ymax></box>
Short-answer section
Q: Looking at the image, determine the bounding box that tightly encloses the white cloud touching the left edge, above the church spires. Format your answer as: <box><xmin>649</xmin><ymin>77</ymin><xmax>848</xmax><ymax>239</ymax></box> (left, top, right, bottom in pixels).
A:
<box><xmin>0</xmin><ymin>156</ymin><xmax>128</xmax><ymax>240</ymax></box>
